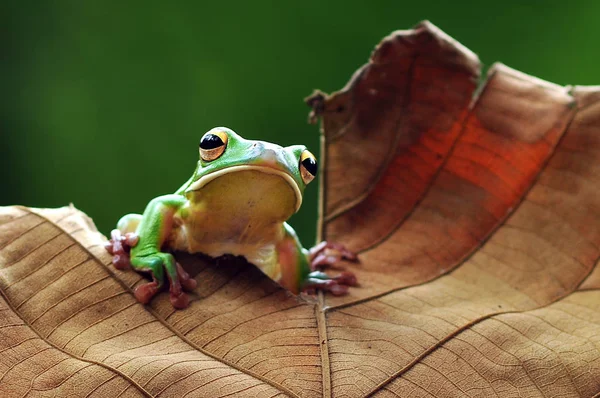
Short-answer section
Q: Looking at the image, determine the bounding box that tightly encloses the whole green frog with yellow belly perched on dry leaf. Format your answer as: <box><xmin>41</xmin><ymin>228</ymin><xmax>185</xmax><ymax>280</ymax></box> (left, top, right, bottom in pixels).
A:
<box><xmin>105</xmin><ymin>127</ymin><xmax>358</xmax><ymax>309</ymax></box>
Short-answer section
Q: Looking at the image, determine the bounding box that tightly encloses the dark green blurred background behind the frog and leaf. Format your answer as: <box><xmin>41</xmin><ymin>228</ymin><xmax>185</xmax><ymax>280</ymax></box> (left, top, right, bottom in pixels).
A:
<box><xmin>0</xmin><ymin>0</ymin><xmax>600</xmax><ymax>245</ymax></box>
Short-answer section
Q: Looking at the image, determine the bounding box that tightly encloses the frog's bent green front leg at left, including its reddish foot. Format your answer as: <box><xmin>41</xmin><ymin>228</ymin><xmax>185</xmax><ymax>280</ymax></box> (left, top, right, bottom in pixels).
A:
<box><xmin>111</xmin><ymin>195</ymin><xmax>196</xmax><ymax>308</ymax></box>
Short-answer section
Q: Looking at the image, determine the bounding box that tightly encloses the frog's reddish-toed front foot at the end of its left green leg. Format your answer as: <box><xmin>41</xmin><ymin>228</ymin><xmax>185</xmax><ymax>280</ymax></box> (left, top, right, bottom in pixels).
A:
<box><xmin>131</xmin><ymin>252</ymin><xmax>196</xmax><ymax>309</ymax></box>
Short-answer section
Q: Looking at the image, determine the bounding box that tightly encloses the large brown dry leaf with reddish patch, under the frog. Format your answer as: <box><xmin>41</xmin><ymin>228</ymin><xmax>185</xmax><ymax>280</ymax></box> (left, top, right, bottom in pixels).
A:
<box><xmin>0</xmin><ymin>23</ymin><xmax>600</xmax><ymax>397</ymax></box>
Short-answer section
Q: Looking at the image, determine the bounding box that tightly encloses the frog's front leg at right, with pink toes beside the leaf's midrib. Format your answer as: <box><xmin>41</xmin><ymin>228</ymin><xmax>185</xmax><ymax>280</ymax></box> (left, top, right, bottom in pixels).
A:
<box><xmin>277</xmin><ymin>223</ymin><xmax>358</xmax><ymax>296</ymax></box>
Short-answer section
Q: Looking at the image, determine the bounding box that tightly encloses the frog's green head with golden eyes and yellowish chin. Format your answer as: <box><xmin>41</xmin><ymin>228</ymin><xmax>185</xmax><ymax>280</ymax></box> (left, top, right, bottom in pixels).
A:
<box><xmin>185</xmin><ymin>127</ymin><xmax>317</xmax><ymax>218</ymax></box>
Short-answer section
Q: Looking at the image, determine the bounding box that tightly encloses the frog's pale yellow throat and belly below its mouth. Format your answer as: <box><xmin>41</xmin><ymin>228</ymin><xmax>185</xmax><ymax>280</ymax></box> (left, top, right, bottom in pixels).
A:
<box><xmin>169</xmin><ymin>170</ymin><xmax>297</xmax><ymax>281</ymax></box>
